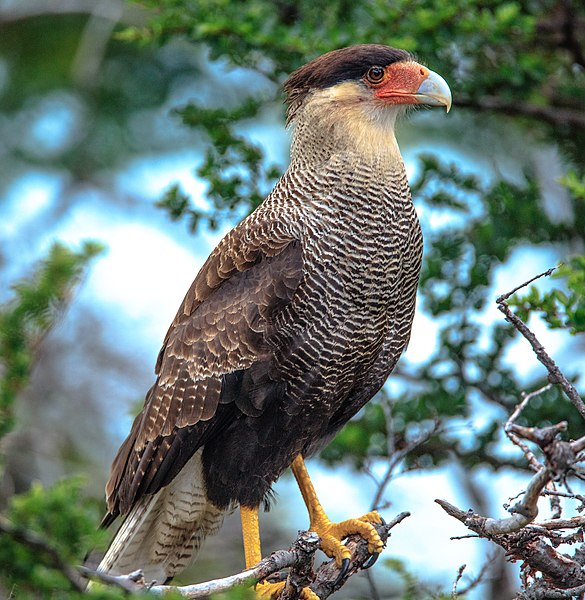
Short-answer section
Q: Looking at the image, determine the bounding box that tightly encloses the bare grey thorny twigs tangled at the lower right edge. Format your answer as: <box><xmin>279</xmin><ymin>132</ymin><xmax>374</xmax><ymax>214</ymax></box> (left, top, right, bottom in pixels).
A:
<box><xmin>436</xmin><ymin>269</ymin><xmax>585</xmax><ymax>600</ymax></box>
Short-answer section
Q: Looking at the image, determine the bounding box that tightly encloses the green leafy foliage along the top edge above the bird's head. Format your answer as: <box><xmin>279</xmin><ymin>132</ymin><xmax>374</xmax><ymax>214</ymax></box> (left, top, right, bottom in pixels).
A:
<box><xmin>120</xmin><ymin>0</ymin><xmax>583</xmax><ymax>107</ymax></box>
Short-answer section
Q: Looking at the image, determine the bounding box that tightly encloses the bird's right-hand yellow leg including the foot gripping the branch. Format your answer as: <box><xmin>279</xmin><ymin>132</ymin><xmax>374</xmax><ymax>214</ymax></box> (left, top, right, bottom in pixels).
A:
<box><xmin>291</xmin><ymin>454</ymin><xmax>384</xmax><ymax>568</ymax></box>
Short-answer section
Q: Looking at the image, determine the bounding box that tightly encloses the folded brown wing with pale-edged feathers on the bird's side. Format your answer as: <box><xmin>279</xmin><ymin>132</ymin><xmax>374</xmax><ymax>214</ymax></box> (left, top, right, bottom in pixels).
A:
<box><xmin>105</xmin><ymin>222</ymin><xmax>303</xmax><ymax>524</ymax></box>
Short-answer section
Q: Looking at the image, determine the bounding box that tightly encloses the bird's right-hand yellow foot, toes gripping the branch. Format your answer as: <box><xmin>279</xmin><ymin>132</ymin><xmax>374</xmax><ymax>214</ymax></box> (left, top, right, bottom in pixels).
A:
<box><xmin>311</xmin><ymin>511</ymin><xmax>384</xmax><ymax>569</ymax></box>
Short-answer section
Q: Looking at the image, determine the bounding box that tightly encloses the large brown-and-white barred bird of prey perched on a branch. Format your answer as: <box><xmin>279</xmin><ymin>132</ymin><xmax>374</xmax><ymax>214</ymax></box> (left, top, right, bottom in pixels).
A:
<box><xmin>98</xmin><ymin>44</ymin><xmax>451</xmax><ymax>600</ymax></box>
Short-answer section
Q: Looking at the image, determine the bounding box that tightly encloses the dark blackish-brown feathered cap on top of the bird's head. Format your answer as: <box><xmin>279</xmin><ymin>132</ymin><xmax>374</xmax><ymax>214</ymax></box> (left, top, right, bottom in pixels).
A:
<box><xmin>284</xmin><ymin>44</ymin><xmax>413</xmax><ymax>123</ymax></box>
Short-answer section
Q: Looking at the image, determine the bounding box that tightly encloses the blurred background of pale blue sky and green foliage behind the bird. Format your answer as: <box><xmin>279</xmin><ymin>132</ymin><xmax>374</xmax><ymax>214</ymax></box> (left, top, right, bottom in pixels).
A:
<box><xmin>0</xmin><ymin>0</ymin><xmax>585</xmax><ymax>599</ymax></box>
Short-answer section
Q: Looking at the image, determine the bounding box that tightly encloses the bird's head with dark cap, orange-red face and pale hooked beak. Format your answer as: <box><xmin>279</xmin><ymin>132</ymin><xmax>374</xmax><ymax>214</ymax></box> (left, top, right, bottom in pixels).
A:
<box><xmin>284</xmin><ymin>44</ymin><xmax>451</xmax><ymax>158</ymax></box>
